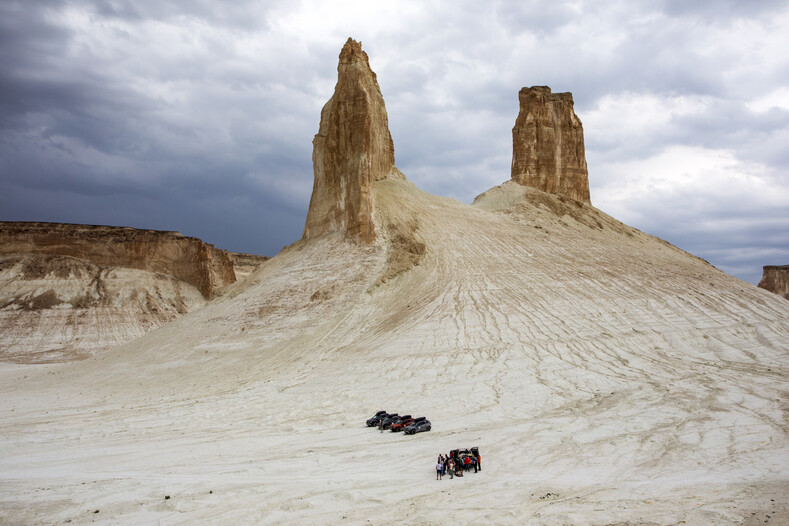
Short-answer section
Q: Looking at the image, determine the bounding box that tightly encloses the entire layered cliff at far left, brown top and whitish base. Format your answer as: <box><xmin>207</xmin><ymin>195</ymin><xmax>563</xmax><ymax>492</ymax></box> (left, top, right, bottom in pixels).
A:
<box><xmin>0</xmin><ymin>222</ymin><xmax>268</xmax><ymax>363</ymax></box>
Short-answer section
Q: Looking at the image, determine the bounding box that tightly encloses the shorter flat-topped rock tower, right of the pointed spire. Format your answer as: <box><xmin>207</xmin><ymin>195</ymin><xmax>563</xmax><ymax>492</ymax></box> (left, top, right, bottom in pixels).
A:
<box><xmin>512</xmin><ymin>86</ymin><xmax>591</xmax><ymax>204</ymax></box>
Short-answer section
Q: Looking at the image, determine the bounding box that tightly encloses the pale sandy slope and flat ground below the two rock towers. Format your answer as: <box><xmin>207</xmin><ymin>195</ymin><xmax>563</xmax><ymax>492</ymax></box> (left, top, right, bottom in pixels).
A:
<box><xmin>0</xmin><ymin>180</ymin><xmax>789</xmax><ymax>524</ymax></box>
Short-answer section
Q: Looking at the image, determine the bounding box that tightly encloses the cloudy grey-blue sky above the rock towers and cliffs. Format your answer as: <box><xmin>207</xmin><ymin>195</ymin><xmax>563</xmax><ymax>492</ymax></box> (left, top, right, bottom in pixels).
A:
<box><xmin>0</xmin><ymin>0</ymin><xmax>789</xmax><ymax>283</ymax></box>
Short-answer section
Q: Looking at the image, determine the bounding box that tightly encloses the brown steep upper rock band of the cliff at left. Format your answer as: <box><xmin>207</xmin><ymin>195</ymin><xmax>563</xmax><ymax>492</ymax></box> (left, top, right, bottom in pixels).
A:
<box><xmin>0</xmin><ymin>222</ymin><xmax>236</xmax><ymax>298</ymax></box>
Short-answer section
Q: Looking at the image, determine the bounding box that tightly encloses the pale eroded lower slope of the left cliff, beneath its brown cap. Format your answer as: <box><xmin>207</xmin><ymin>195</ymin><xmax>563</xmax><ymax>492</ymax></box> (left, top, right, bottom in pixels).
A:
<box><xmin>0</xmin><ymin>254</ymin><xmax>206</xmax><ymax>363</ymax></box>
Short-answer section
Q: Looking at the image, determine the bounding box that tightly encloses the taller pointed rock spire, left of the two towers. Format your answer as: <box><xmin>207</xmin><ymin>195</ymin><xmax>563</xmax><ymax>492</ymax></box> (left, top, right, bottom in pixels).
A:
<box><xmin>303</xmin><ymin>38</ymin><xmax>399</xmax><ymax>243</ymax></box>
